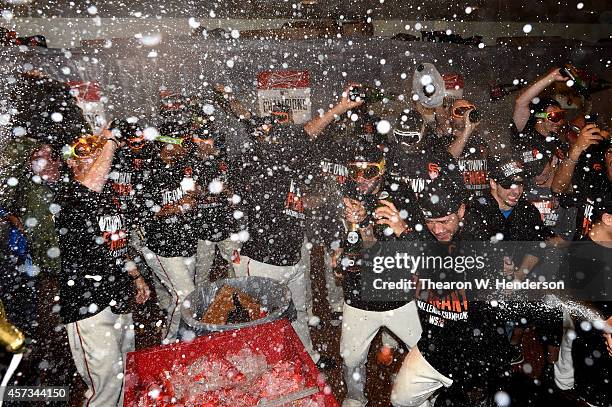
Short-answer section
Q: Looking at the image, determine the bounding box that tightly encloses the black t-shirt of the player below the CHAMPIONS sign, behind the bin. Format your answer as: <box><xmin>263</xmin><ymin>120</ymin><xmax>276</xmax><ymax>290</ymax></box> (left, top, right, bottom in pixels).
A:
<box><xmin>240</xmin><ymin>126</ymin><xmax>316</xmax><ymax>266</ymax></box>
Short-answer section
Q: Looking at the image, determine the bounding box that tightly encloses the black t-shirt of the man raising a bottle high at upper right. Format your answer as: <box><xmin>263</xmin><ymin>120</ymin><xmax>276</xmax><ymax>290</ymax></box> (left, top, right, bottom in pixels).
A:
<box><xmin>510</xmin><ymin>121</ymin><xmax>566</xmax><ymax>177</ymax></box>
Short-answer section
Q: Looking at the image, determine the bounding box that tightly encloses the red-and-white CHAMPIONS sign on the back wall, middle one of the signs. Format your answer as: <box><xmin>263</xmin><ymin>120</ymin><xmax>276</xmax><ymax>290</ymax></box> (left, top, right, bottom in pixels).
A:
<box><xmin>257</xmin><ymin>71</ymin><xmax>311</xmax><ymax>124</ymax></box>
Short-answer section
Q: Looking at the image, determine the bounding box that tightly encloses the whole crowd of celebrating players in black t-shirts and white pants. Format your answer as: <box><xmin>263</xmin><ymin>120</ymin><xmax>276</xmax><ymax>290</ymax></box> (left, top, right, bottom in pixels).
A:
<box><xmin>0</xmin><ymin>64</ymin><xmax>612</xmax><ymax>407</ymax></box>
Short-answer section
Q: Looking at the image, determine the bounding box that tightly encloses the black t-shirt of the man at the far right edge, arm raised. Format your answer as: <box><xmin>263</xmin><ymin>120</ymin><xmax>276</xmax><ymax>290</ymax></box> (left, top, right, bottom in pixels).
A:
<box><xmin>560</xmin><ymin>148</ymin><xmax>610</xmax><ymax>240</ymax></box>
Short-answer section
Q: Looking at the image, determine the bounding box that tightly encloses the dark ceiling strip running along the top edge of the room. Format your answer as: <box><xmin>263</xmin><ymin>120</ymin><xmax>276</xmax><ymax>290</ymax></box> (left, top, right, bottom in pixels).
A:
<box><xmin>0</xmin><ymin>0</ymin><xmax>612</xmax><ymax>24</ymax></box>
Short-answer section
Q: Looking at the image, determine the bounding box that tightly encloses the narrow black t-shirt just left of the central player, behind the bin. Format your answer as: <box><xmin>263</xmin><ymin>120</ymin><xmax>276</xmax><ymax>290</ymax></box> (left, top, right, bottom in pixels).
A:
<box><xmin>194</xmin><ymin>155</ymin><xmax>238</xmax><ymax>242</ymax></box>
